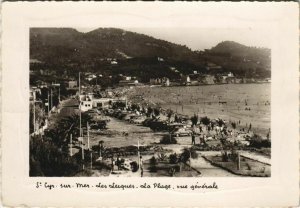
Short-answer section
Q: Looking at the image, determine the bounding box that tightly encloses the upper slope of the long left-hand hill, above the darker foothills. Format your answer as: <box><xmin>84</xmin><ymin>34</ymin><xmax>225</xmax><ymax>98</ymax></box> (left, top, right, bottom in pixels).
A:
<box><xmin>30</xmin><ymin>28</ymin><xmax>199</xmax><ymax>66</ymax></box>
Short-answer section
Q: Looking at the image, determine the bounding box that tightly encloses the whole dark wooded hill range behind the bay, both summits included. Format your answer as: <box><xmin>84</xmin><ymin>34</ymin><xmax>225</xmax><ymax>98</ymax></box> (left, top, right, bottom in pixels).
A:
<box><xmin>30</xmin><ymin>28</ymin><xmax>270</xmax><ymax>81</ymax></box>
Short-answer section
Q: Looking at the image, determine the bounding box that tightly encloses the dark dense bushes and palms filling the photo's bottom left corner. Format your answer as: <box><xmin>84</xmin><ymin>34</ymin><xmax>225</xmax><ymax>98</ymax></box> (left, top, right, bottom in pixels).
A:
<box><xmin>30</xmin><ymin>114</ymin><xmax>91</xmax><ymax>176</ymax></box>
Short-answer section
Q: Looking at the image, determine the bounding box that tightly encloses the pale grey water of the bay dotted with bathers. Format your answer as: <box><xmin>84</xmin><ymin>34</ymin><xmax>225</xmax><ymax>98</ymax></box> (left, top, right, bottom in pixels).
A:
<box><xmin>120</xmin><ymin>83</ymin><xmax>271</xmax><ymax>137</ymax></box>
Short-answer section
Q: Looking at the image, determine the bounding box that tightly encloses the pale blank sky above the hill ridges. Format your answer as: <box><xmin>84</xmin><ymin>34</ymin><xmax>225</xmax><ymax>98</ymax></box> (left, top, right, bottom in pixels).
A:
<box><xmin>76</xmin><ymin>27</ymin><xmax>272</xmax><ymax>50</ymax></box>
